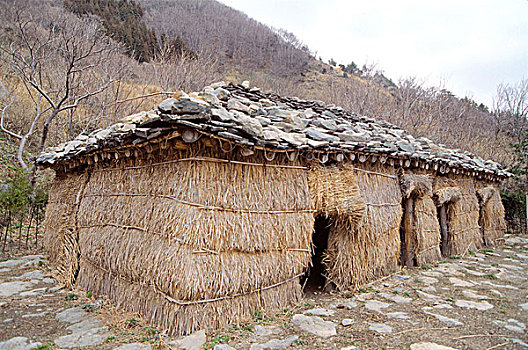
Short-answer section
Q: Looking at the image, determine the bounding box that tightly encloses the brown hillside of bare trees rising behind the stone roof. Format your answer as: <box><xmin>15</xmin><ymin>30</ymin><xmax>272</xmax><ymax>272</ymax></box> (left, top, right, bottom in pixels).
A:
<box><xmin>0</xmin><ymin>0</ymin><xmax>511</xmax><ymax>168</ymax></box>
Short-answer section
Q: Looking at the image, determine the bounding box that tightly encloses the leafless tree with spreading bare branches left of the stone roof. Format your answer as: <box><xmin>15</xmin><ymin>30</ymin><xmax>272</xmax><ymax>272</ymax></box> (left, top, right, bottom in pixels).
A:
<box><xmin>0</xmin><ymin>1</ymin><xmax>125</xmax><ymax>182</ymax></box>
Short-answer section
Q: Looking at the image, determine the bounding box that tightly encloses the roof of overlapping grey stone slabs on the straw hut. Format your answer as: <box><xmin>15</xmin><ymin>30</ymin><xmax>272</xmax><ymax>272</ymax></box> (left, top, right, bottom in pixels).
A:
<box><xmin>36</xmin><ymin>82</ymin><xmax>510</xmax><ymax>177</ymax></box>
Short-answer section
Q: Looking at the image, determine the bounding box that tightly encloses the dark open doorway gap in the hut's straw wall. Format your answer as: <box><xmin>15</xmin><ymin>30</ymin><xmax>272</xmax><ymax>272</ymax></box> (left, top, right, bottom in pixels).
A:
<box><xmin>301</xmin><ymin>216</ymin><xmax>330</xmax><ymax>293</ymax></box>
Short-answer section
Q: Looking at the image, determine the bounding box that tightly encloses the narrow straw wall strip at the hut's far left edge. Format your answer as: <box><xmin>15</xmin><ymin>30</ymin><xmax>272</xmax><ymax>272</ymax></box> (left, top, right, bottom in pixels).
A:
<box><xmin>44</xmin><ymin>173</ymin><xmax>89</xmax><ymax>287</ymax></box>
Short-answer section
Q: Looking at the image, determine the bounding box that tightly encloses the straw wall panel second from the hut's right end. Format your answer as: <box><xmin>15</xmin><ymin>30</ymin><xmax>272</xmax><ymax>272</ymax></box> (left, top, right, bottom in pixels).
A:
<box><xmin>434</xmin><ymin>176</ymin><xmax>482</xmax><ymax>255</ymax></box>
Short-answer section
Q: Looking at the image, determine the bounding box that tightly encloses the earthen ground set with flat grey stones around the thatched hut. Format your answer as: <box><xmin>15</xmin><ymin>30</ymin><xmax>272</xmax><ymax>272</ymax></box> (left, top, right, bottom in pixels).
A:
<box><xmin>0</xmin><ymin>236</ymin><xmax>528</xmax><ymax>350</ymax></box>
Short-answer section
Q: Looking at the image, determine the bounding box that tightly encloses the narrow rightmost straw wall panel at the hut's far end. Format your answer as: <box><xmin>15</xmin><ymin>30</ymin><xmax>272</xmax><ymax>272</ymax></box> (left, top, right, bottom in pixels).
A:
<box><xmin>477</xmin><ymin>185</ymin><xmax>506</xmax><ymax>246</ymax></box>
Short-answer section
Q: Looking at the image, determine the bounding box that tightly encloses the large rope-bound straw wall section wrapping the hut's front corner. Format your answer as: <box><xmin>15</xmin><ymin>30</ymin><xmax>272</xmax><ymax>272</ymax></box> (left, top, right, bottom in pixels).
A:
<box><xmin>74</xmin><ymin>142</ymin><xmax>314</xmax><ymax>334</ymax></box>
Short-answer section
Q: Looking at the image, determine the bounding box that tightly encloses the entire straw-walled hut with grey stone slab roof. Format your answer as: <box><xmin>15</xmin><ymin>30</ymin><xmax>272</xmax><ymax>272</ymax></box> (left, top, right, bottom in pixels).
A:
<box><xmin>37</xmin><ymin>83</ymin><xmax>508</xmax><ymax>334</ymax></box>
